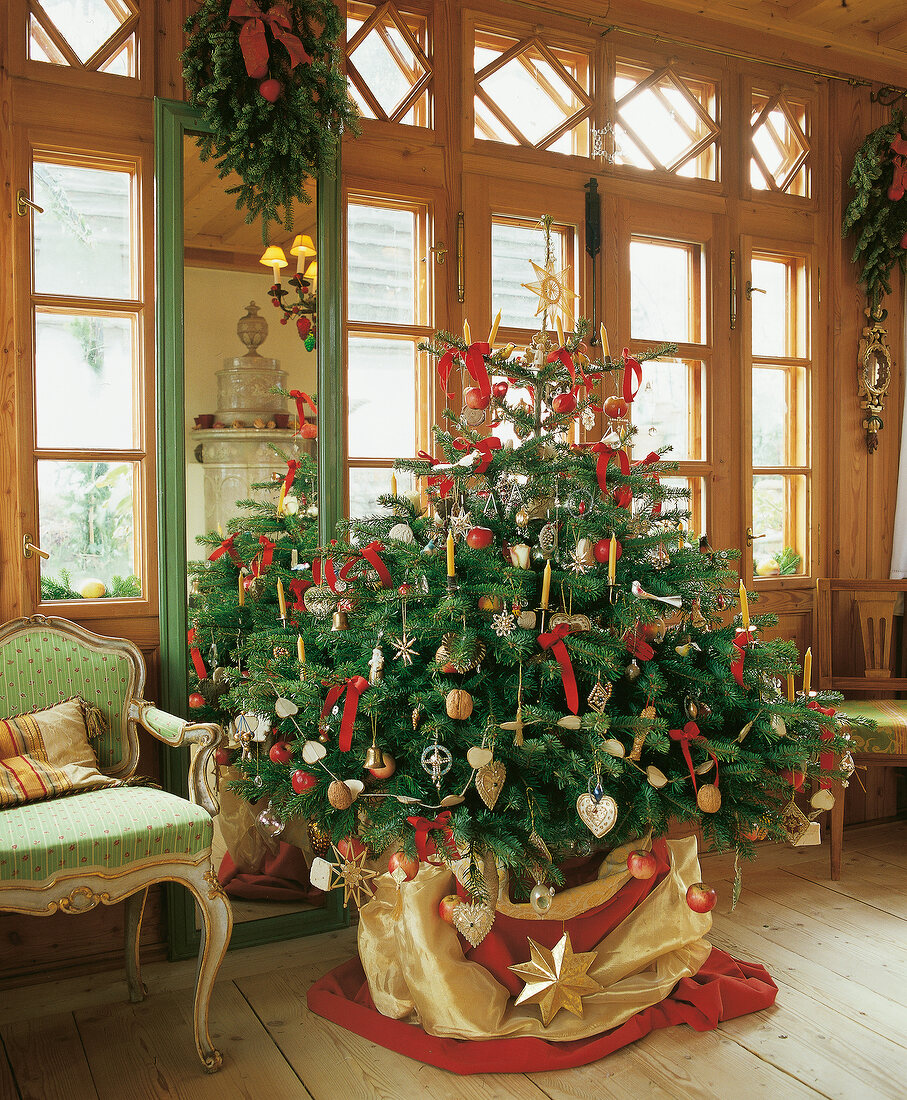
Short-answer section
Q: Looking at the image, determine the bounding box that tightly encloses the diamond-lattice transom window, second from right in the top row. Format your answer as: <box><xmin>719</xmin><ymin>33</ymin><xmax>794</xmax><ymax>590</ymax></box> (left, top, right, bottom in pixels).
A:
<box><xmin>615</xmin><ymin>65</ymin><xmax>720</xmax><ymax>179</ymax></box>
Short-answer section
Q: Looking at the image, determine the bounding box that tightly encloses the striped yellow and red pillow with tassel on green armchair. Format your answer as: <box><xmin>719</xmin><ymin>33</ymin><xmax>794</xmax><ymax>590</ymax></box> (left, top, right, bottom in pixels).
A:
<box><xmin>0</xmin><ymin>699</ymin><xmax>119</xmax><ymax>810</ymax></box>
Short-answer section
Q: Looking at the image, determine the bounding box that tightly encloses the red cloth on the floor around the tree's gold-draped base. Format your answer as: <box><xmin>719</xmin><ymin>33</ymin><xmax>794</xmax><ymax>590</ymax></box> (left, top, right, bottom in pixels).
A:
<box><xmin>308</xmin><ymin>947</ymin><xmax>777</xmax><ymax>1074</ymax></box>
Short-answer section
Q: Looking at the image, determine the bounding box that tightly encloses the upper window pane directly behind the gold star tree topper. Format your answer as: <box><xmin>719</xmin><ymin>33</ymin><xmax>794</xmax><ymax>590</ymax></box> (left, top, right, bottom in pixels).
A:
<box><xmin>491</xmin><ymin>221</ymin><xmax>575</xmax><ymax>332</ymax></box>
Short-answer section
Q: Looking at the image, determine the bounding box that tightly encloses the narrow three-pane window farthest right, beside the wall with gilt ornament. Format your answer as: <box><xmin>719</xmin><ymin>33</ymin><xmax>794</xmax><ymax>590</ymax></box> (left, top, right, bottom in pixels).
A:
<box><xmin>751</xmin><ymin>252</ymin><xmax>811</xmax><ymax>576</ymax></box>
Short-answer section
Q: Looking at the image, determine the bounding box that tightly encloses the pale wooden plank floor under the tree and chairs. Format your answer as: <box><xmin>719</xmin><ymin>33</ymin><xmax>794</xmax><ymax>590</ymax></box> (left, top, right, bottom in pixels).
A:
<box><xmin>0</xmin><ymin>822</ymin><xmax>907</xmax><ymax>1100</ymax></box>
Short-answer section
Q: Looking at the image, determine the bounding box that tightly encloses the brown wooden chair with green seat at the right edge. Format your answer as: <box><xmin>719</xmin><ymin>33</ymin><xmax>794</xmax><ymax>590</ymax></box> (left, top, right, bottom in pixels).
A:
<box><xmin>812</xmin><ymin>580</ymin><xmax>907</xmax><ymax>879</ymax></box>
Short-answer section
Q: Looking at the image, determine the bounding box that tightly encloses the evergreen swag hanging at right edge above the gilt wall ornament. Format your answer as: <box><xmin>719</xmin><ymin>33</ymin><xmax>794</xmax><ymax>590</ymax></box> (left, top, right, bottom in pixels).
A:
<box><xmin>841</xmin><ymin>111</ymin><xmax>907</xmax><ymax>309</ymax></box>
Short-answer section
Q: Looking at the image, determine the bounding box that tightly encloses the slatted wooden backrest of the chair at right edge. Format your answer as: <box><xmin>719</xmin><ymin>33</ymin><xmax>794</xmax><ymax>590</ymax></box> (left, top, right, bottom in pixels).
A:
<box><xmin>814</xmin><ymin>579</ymin><xmax>907</xmax><ymax>696</ymax></box>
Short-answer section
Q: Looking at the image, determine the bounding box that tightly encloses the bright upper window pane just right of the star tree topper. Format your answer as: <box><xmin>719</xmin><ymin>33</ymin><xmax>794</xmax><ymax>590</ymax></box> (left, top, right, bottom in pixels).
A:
<box><xmin>630</xmin><ymin>240</ymin><xmax>703</xmax><ymax>343</ymax></box>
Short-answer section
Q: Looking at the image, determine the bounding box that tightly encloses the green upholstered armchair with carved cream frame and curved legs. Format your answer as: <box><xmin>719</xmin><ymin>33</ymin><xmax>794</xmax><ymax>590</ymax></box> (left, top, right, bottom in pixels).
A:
<box><xmin>0</xmin><ymin>615</ymin><xmax>233</xmax><ymax>1073</ymax></box>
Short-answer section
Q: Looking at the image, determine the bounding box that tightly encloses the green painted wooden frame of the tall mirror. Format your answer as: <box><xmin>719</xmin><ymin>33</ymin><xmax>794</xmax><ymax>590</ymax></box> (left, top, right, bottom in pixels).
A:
<box><xmin>154</xmin><ymin>99</ymin><xmax>347</xmax><ymax>958</ymax></box>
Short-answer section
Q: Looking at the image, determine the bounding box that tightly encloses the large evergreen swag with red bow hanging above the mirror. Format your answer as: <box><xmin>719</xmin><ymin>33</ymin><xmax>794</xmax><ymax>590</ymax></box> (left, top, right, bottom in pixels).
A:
<box><xmin>181</xmin><ymin>0</ymin><xmax>358</xmax><ymax>232</ymax></box>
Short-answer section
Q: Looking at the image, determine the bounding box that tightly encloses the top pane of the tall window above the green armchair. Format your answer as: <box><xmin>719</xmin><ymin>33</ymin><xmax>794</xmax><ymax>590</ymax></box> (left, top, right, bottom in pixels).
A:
<box><xmin>33</xmin><ymin>161</ymin><xmax>133</xmax><ymax>298</ymax></box>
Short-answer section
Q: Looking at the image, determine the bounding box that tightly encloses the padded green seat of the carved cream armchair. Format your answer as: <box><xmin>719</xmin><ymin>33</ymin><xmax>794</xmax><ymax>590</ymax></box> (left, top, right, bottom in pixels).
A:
<box><xmin>0</xmin><ymin>787</ymin><xmax>214</xmax><ymax>884</ymax></box>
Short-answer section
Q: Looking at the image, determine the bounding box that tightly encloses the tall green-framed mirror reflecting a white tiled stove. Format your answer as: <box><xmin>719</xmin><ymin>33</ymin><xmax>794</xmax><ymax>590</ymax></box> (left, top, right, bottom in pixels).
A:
<box><xmin>157</xmin><ymin>101</ymin><xmax>343</xmax><ymax>955</ymax></box>
